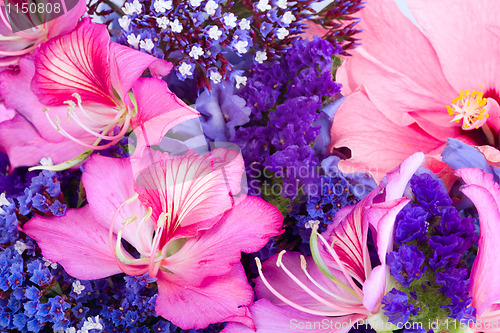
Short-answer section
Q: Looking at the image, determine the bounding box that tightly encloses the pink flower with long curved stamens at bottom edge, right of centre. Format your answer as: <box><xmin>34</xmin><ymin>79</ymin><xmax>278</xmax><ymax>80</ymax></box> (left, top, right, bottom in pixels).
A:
<box><xmin>224</xmin><ymin>153</ymin><xmax>424</xmax><ymax>333</ymax></box>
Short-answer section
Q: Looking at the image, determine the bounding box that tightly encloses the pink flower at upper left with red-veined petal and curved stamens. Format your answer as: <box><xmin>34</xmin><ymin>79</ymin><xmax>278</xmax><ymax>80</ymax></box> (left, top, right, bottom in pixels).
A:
<box><xmin>0</xmin><ymin>18</ymin><xmax>199</xmax><ymax>169</ymax></box>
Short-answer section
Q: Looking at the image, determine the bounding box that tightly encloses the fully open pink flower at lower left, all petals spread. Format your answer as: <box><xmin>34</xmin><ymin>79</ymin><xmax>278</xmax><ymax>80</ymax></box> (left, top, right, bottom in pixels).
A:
<box><xmin>24</xmin><ymin>148</ymin><xmax>282</xmax><ymax>329</ymax></box>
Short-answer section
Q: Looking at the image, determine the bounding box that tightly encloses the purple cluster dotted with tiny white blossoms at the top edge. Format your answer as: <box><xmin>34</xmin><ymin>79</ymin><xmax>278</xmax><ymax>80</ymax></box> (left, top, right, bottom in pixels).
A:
<box><xmin>114</xmin><ymin>0</ymin><xmax>317</xmax><ymax>87</ymax></box>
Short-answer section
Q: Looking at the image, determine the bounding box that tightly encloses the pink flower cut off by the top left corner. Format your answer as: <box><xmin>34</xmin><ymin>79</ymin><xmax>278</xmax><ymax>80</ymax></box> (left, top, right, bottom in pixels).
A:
<box><xmin>0</xmin><ymin>0</ymin><xmax>86</xmax><ymax>71</ymax></box>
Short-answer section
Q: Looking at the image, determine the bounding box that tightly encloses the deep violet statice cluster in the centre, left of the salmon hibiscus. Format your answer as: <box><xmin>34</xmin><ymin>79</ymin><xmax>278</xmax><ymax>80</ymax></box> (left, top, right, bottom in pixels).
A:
<box><xmin>233</xmin><ymin>38</ymin><xmax>341</xmax><ymax>199</ymax></box>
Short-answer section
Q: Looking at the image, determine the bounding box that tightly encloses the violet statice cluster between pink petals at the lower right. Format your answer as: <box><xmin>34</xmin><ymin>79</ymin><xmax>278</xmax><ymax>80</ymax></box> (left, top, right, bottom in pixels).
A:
<box><xmin>383</xmin><ymin>173</ymin><xmax>478</xmax><ymax>324</ymax></box>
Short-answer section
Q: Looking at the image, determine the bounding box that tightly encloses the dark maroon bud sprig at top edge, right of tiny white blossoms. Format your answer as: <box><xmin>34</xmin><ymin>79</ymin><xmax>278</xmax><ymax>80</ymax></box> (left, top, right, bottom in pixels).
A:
<box><xmin>312</xmin><ymin>0</ymin><xmax>366</xmax><ymax>56</ymax></box>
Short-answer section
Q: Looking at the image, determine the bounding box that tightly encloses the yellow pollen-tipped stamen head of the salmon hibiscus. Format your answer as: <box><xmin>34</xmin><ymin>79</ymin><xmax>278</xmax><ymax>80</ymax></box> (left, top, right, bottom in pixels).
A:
<box><xmin>446</xmin><ymin>90</ymin><xmax>489</xmax><ymax>131</ymax></box>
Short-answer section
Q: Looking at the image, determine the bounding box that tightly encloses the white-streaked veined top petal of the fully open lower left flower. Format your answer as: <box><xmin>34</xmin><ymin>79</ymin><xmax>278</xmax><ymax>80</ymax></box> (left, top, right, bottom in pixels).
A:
<box><xmin>135</xmin><ymin>148</ymin><xmax>244</xmax><ymax>238</ymax></box>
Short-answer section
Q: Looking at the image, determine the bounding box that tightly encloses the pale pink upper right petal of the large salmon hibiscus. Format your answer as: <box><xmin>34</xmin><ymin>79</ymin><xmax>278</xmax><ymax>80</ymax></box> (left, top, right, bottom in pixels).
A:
<box><xmin>408</xmin><ymin>0</ymin><xmax>500</xmax><ymax>92</ymax></box>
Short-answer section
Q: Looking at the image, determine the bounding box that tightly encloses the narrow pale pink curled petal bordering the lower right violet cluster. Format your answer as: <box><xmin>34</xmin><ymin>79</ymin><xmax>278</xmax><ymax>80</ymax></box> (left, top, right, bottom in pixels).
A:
<box><xmin>363</xmin><ymin>197</ymin><xmax>410</xmax><ymax>313</ymax></box>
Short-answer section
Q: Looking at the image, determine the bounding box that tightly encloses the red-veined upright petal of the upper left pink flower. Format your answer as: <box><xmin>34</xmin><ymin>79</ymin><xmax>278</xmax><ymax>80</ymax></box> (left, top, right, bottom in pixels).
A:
<box><xmin>31</xmin><ymin>18</ymin><xmax>116</xmax><ymax>106</ymax></box>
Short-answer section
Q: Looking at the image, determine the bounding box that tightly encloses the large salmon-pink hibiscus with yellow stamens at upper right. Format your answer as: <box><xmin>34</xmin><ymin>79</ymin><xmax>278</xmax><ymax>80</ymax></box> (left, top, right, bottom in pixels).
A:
<box><xmin>331</xmin><ymin>0</ymin><xmax>500</xmax><ymax>180</ymax></box>
